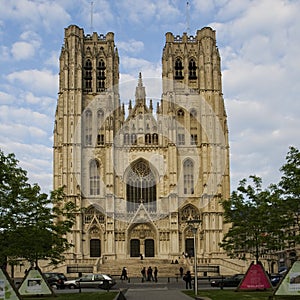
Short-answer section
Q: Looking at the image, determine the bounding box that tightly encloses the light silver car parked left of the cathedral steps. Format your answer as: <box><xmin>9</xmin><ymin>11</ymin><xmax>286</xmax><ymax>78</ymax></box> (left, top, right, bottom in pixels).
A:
<box><xmin>64</xmin><ymin>274</ymin><xmax>116</xmax><ymax>290</ymax></box>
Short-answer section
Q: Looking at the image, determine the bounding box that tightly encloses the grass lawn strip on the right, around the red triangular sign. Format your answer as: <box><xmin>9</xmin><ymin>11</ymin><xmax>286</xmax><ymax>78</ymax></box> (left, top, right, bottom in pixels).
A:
<box><xmin>183</xmin><ymin>290</ymin><xmax>299</xmax><ymax>300</ymax></box>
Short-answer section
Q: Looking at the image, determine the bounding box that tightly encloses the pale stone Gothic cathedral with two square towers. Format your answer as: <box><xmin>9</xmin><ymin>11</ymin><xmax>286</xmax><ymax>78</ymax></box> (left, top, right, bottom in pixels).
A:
<box><xmin>53</xmin><ymin>25</ymin><xmax>230</xmax><ymax>270</ymax></box>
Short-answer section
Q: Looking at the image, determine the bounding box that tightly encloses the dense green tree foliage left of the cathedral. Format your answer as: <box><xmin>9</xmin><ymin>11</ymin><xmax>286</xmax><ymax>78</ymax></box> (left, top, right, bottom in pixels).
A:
<box><xmin>0</xmin><ymin>150</ymin><xmax>77</xmax><ymax>266</ymax></box>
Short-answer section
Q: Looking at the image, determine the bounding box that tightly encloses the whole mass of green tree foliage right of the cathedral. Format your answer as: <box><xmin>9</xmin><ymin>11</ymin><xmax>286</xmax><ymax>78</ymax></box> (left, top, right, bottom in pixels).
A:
<box><xmin>220</xmin><ymin>147</ymin><xmax>300</xmax><ymax>261</ymax></box>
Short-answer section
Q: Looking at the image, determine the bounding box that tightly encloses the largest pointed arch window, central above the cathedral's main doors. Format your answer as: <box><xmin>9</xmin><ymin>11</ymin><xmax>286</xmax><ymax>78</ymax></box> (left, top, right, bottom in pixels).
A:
<box><xmin>126</xmin><ymin>159</ymin><xmax>156</xmax><ymax>212</ymax></box>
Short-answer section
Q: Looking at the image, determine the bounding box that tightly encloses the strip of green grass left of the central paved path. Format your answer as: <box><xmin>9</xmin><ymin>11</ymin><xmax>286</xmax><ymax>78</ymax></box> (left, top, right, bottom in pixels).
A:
<box><xmin>25</xmin><ymin>292</ymin><xmax>118</xmax><ymax>300</ymax></box>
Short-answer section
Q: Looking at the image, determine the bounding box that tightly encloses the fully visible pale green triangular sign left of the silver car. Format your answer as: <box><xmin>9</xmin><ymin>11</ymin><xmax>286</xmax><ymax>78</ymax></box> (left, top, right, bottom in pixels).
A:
<box><xmin>17</xmin><ymin>267</ymin><xmax>55</xmax><ymax>299</ymax></box>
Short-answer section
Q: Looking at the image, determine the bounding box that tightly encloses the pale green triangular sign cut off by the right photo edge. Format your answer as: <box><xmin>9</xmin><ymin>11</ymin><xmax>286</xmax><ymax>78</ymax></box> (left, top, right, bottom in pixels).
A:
<box><xmin>273</xmin><ymin>261</ymin><xmax>300</xmax><ymax>297</ymax></box>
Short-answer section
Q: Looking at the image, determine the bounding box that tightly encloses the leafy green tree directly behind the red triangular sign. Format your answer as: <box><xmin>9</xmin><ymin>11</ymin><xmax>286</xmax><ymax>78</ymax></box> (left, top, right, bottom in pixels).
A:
<box><xmin>220</xmin><ymin>176</ymin><xmax>286</xmax><ymax>262</ymax></box>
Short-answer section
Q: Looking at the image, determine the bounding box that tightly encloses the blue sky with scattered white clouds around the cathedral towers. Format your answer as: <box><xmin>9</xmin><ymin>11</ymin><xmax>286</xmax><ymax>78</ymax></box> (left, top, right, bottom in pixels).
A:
<box><xmin>0</xmin><ymin>0</ymin><xmax>300</xmax><ymax>193</ymax></box>
